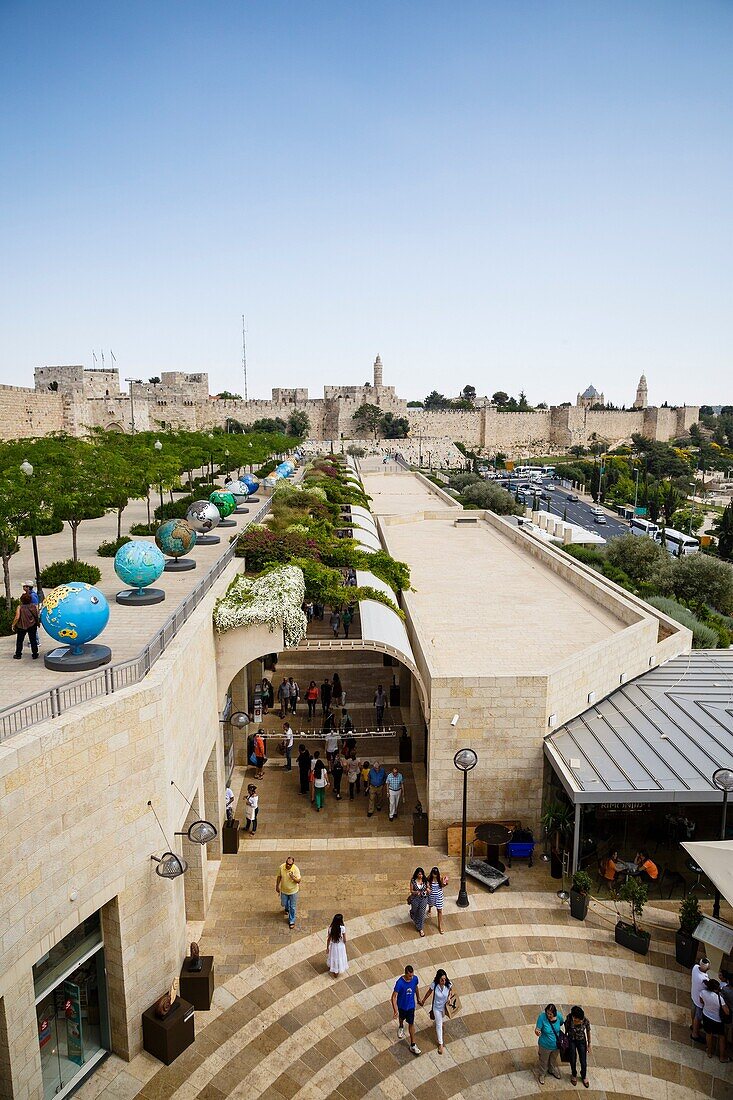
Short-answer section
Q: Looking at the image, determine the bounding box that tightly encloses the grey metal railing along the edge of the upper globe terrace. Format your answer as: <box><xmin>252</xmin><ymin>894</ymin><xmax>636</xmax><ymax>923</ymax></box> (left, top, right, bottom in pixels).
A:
<box><xmin>0</xmin><ymin>497</ymin><xmax>272</xmax><ymax>741</ymax></box>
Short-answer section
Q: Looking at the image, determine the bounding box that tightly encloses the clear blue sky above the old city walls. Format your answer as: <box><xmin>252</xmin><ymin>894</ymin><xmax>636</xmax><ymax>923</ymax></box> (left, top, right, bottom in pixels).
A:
<box><xmin>0</xmin><ymin>0</ymin><xmax>733</xmax><ymax>404</ymax></box>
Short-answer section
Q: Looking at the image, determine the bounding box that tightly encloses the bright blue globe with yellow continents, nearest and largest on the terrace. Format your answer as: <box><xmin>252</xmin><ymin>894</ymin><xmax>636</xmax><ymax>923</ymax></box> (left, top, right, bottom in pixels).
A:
<box><xmin>41</xmin><ymin>581</ymin><xmax>112</xmax><ymax>672</ymax></box>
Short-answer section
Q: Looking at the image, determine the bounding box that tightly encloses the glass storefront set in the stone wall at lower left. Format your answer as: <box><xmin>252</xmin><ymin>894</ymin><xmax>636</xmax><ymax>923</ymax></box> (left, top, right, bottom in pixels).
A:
<box><xmin>33</xmin><ymin>913</ymin><xmax>110</xmax><ymax>1100</ymax></box>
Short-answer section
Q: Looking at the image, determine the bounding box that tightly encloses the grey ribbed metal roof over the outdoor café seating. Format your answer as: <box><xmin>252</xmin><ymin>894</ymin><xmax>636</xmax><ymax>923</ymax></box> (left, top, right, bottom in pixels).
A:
<box><xmin>545</xmin><ymin>649</ymin><xmax>733</xmax><ymax>803</ymax></box>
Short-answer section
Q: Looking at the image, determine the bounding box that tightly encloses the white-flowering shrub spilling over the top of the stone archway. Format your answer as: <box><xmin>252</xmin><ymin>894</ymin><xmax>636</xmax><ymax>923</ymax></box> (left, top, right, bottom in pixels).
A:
<box><xmin>214</xmin><ymin>565</ymin><xmax>307</xmax><ymax>649</ymax></box>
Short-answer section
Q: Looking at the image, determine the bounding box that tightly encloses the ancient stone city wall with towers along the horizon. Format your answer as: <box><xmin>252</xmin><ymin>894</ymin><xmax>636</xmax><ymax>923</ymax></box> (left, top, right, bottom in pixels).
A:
<box><xmin>0</xmin><ymin>355</ymin><xmax>700</xmax><ymax>458</ymax></box>
